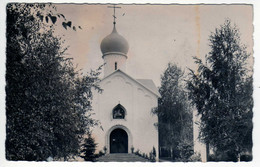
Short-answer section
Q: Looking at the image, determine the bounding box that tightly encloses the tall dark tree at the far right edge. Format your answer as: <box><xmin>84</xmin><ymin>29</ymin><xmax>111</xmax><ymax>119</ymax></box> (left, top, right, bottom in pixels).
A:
<box><xmin>188</xmin><ymin>20</ymin><xmax>253</xmax><ymax>161</ymax></box>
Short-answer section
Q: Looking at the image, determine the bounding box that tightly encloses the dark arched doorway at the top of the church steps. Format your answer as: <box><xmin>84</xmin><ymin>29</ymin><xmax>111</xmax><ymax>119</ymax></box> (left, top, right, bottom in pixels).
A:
<box><xmin>110</xmin><ymin>128</ymin><xmax>128</xmax><ymax>153</ymax></box>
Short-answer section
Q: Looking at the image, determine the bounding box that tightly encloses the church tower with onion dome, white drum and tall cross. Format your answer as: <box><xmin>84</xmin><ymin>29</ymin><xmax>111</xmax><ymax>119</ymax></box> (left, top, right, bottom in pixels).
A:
<box><xmin>100</xmin><ymin>5</ymin><xmax>129</xmax><ymax>76</ymax></box>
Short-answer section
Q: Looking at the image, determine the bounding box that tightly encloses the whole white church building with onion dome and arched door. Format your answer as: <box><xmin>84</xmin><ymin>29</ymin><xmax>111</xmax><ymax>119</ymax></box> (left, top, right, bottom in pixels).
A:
<box><xmin>92</xmin><ymin>22</ymin><xmax>160</xmax><ymax>160</ymax></box>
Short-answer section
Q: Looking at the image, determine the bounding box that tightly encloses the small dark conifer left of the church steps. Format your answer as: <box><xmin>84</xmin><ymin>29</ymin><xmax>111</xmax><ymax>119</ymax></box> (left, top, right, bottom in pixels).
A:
<box><xmin>80</xmin><ymin>134</ymin><xmax>97</xmax><ymax>162</ymax></box>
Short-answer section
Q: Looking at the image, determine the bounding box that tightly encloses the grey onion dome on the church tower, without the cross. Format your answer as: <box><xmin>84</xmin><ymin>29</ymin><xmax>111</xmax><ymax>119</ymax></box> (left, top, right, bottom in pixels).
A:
<box><xmin>100</xmin><ymin>26</ymin><xmax>129</xmax><ymax>56</ymax></box>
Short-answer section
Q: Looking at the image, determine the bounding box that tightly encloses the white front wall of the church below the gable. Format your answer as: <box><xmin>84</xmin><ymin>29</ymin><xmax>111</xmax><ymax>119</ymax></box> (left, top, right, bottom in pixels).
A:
<box><xmin>93</xmin><ymin>71</ymin><xmax>158</xmax><ymax>158</ymax></box>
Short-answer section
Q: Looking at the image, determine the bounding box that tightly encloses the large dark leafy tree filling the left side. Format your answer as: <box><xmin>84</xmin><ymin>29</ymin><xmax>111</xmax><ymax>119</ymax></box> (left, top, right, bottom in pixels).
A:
<box><xmin>6</xmin><ymin>3</ymin><xmax>101</xmax><ymax>161</ymax></box>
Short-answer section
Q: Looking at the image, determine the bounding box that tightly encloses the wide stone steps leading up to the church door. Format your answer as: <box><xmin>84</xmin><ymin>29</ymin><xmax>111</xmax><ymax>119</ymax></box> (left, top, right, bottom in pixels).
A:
<box><xmin>97</xmin><ymin>153</ymin><xmax>149</xmax><ymax>162</ymax></box>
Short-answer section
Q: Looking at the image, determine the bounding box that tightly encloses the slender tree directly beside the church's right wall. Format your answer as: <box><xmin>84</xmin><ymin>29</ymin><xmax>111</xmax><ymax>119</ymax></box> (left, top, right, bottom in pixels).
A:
<box><xmin>154</xmin><ymin>63</ymin><xmax>193</xmax><ymax>161</ymax></box>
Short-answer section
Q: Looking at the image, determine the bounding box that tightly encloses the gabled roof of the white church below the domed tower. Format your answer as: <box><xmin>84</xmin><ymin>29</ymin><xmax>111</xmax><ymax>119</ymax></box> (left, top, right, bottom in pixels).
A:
<box><xmin>101</xmin><ymin>69</ymin><xmax>161</xmax><ymax>97</ymax></box>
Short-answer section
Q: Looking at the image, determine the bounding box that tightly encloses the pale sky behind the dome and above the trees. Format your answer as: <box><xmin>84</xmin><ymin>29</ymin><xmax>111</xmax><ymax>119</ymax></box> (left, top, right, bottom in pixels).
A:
<box><xmin>55</xmin><ymin>4</ymin><xmax>253</xmax><ymax>86</ymax></box>
